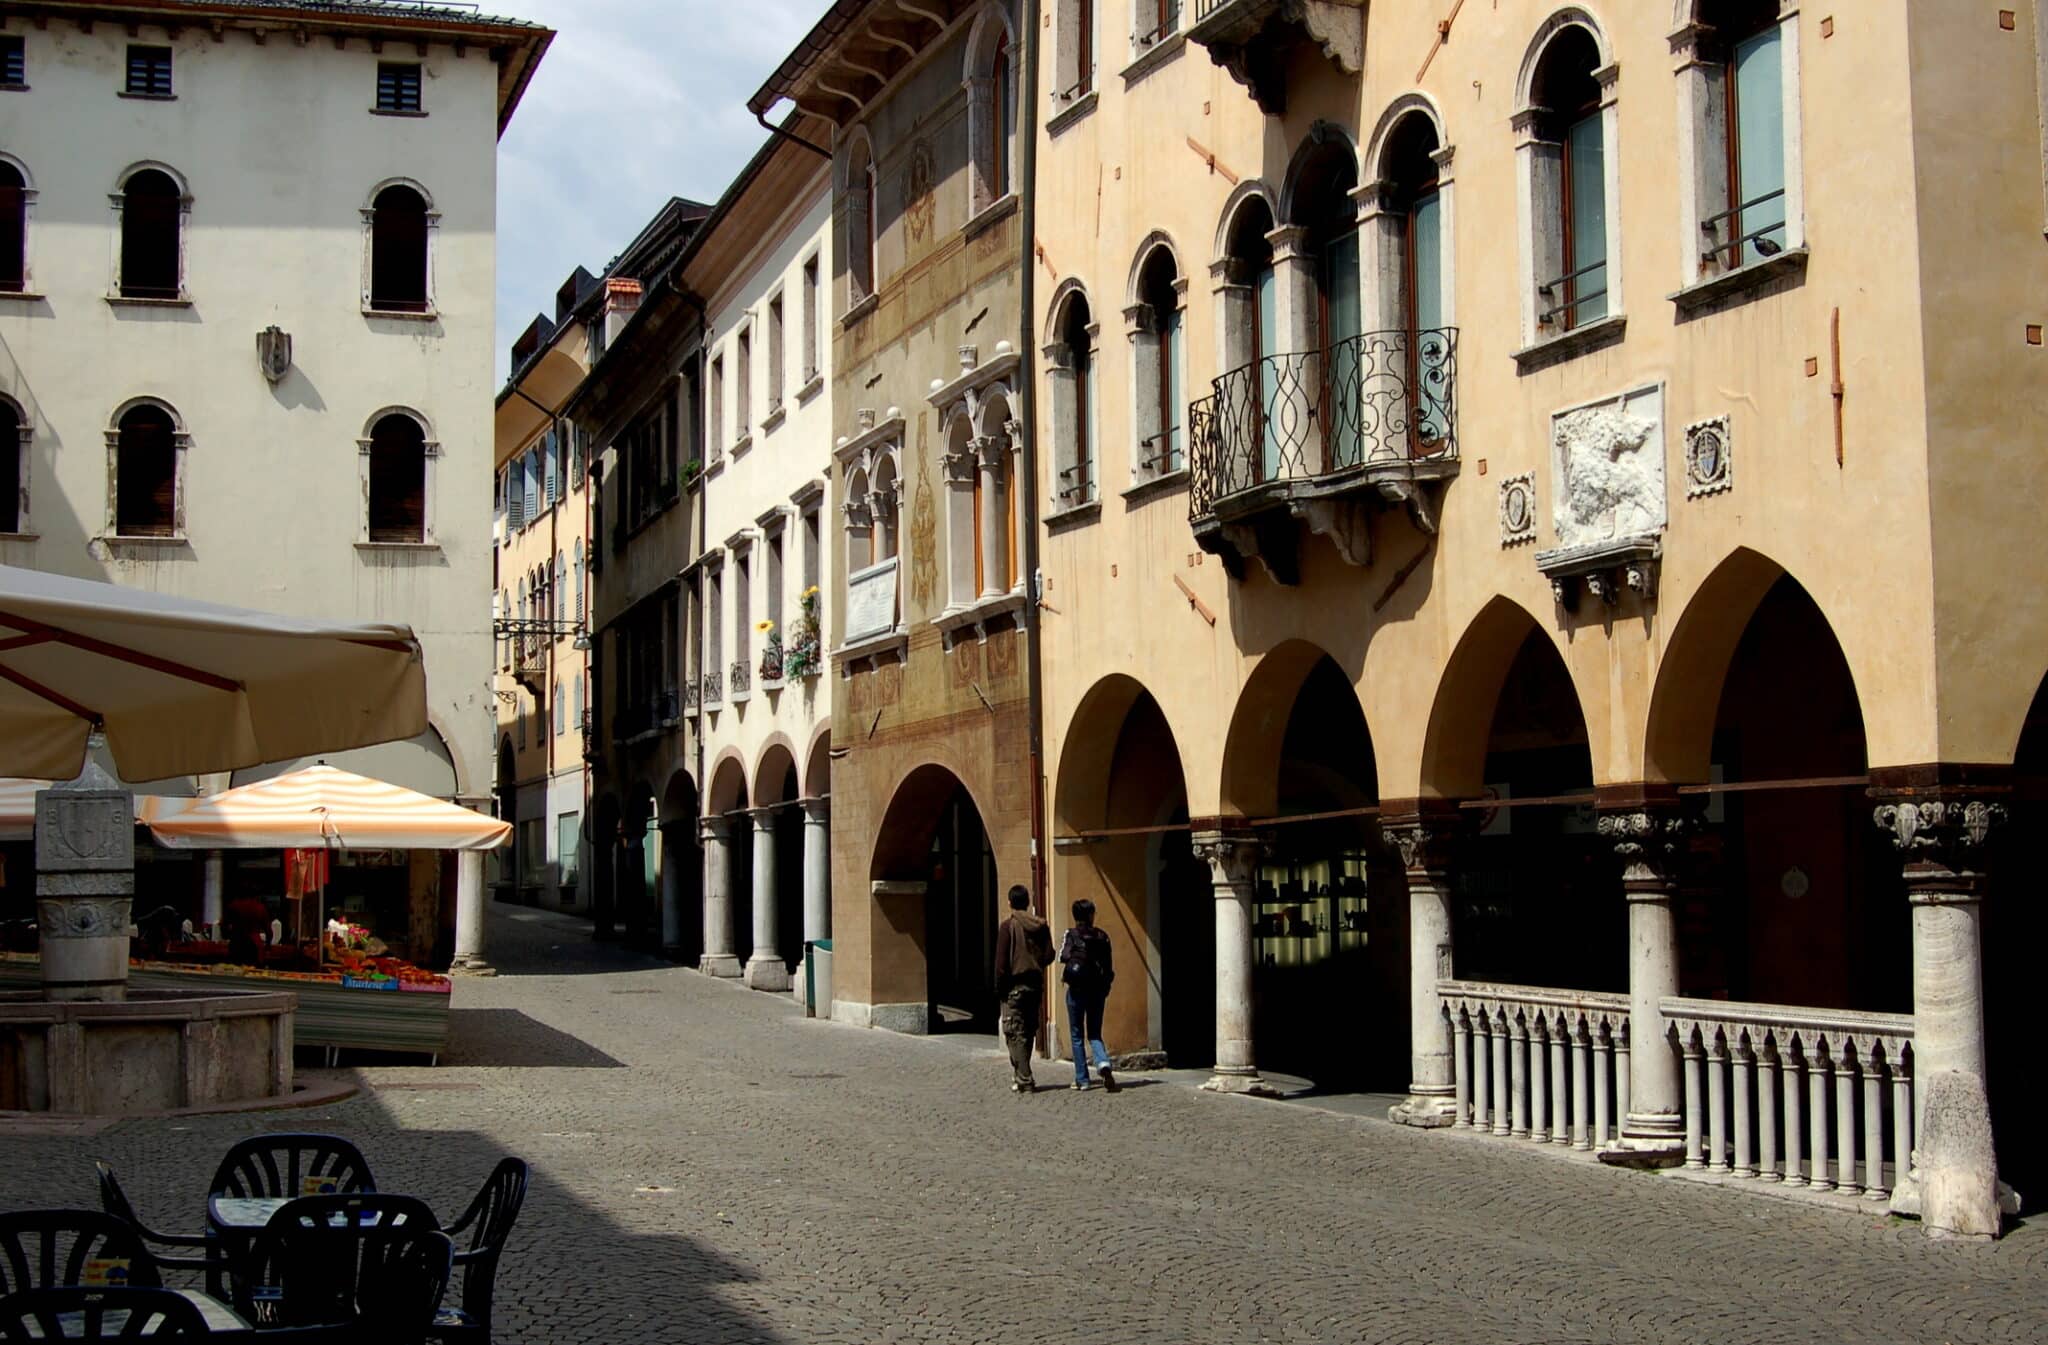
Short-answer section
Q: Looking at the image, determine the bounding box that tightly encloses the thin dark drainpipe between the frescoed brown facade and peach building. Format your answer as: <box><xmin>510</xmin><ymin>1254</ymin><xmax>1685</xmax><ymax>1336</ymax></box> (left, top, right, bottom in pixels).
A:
<box><xmin>1018</xmin><ymin>0</ymin><xmax>1047</xmax><ymax>915</ymax></box>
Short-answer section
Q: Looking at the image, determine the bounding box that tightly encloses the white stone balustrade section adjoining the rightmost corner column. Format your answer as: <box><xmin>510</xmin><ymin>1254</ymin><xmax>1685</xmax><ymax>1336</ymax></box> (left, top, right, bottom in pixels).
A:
<box><xmin>1663</xmin><ymin>999</ymin><xmax>1913</xmax><ymax>1200</ymax></box>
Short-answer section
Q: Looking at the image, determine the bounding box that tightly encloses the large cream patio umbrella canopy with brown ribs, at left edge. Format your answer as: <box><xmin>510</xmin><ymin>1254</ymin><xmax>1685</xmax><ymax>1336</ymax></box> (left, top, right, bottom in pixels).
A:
<box><xmin>0</xmin><ymin>565</ymin><xmax>426</xmax><ymax>780</ymax></box>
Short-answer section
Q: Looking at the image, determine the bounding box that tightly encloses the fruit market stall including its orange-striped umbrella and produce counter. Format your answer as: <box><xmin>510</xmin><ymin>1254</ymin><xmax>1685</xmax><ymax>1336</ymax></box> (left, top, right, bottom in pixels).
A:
<box><xmin>135</xmin><ymin>766</ymin><xmax>512</xmax><ymax>1056</ymax></box>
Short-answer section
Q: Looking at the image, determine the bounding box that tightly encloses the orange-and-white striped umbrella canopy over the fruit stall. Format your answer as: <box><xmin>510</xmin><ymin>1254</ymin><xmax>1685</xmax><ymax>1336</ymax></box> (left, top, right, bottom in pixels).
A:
<box><xmin>150</xmin><ymin>766</ymin><xmax>512</xmax><ymax>850</ymax></box>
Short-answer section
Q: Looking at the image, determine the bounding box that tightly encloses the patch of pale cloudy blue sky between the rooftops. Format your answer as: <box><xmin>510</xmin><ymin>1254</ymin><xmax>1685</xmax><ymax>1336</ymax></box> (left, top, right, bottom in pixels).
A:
<box><xmin>479</xmin><ymin>0</ymin><xmax>829</xmax><ymax>383</ymax></box>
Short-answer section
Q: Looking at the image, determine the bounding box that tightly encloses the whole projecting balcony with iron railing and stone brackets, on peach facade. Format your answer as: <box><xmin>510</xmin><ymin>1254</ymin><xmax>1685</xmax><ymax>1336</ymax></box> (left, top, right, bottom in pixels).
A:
<box><xmin>1188</xmin><ymin>328</ymin><xmax>1458</xmax><ymax>583</ymax></box>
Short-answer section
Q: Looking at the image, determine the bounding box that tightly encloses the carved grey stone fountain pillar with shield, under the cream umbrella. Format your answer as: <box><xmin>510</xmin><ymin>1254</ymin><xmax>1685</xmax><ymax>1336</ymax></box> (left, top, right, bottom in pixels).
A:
<box><xmin>35</xmin><ymin>761</ymin><xmax>135</xmax><ymax>1003</ymax></box>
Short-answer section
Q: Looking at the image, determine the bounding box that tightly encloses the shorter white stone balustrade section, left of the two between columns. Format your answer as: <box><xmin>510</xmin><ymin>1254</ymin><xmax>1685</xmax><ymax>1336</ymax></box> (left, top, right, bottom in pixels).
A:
<box><xmin>1436</xmin><ymin>981</ymin><xmax>1628</xmax><ymax>1148</ymax></box>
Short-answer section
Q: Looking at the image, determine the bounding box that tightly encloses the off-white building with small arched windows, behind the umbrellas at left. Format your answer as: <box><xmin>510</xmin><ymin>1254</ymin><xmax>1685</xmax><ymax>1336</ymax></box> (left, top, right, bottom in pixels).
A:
<box><xmin>0</xmin><ymin>0</ymin><xmax>551</xmax><ymax>958</ymax></box>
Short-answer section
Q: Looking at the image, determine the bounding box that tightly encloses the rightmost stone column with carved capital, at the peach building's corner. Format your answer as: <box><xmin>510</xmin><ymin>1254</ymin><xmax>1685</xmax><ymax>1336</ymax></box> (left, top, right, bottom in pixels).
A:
<box><xmin>1872</xmin><ymin>788</ymin><xmax>2005</xmax><ymax>1236</ymax></box>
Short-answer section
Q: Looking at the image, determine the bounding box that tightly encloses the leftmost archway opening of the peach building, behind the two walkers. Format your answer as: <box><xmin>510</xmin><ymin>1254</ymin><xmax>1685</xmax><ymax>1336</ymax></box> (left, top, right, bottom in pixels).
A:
<box><xmin>1055</xmin><ymin>674</ymin><xmax>1217</xmax><ymax>1069</ymax></box>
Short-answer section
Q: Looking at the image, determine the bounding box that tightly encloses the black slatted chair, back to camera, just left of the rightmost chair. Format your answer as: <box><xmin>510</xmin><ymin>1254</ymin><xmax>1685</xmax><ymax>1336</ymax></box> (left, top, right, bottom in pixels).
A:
<box><xmin>233</xmin><ymin>1191</ymin><xmax>455</xmax><ymax>1345</ymax></box>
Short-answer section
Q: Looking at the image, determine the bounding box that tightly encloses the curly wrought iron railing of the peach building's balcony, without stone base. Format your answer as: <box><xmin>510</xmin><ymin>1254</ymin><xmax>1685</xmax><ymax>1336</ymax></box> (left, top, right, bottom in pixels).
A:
<box><xmin>1188</xmin><ymin>328</ymin><xmax>1458</xmax><ymax>518</ymax></box>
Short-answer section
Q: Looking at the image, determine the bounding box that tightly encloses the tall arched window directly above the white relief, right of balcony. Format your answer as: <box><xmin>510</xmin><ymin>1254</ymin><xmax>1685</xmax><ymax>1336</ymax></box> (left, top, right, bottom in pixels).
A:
<box><xmin>1516</xmin><ymin>23</ymin><xmax>1612</xmax><ymax>340</ymax></box>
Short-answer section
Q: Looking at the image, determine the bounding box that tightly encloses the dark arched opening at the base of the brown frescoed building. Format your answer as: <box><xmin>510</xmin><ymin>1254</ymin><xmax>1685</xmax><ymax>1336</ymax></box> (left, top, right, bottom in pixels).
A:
<box><xmin>870</xmin><ymin>764</ymin><xmax>995</xmax><ymax>1032</ymax></box>
